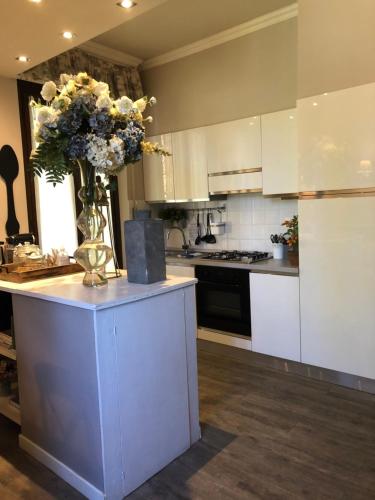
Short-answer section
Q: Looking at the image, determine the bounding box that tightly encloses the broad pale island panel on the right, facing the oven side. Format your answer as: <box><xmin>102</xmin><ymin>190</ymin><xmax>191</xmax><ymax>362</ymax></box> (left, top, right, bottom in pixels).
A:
<box><xmin>97</xmin><ymin>288</ymin><xmax>195</xmax><ymax>498</ymax></box>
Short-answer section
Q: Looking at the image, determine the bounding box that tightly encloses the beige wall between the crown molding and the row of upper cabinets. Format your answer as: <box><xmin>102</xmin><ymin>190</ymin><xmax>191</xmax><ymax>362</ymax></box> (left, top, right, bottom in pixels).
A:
<box><xmin>141</xmin><ymin>19</ymin><xmax>297</xmax><ymax>135</ymax></box>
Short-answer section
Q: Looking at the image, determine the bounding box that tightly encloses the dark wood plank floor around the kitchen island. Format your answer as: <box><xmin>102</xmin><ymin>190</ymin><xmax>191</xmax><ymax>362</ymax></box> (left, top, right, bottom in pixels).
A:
<box><xmin>0</xmin><ymin>349</ymin><xmax>375</xmax><ymax>500</ymax></box>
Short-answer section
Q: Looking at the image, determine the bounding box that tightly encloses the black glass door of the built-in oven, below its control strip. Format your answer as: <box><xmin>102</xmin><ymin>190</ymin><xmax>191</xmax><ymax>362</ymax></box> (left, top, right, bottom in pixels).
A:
<box><xmin>197</xmin><ymin>281</ymin><xmax>251</xmax><ymax>336</ymax></box>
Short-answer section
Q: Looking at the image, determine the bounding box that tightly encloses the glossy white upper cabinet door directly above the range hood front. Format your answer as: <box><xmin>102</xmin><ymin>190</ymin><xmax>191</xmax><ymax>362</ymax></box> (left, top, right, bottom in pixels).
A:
<box><xmin>204</xmin><ymin>116</ymin><xmax>261</xmax><ymax>174</ymax></box>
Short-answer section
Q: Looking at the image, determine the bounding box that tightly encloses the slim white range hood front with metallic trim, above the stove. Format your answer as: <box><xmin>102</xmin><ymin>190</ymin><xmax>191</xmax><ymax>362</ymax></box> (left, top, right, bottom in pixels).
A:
<box><xmin>208</xmin><ymin>172</ymin><xmax>262</xmax><ymax>194</ymax></box>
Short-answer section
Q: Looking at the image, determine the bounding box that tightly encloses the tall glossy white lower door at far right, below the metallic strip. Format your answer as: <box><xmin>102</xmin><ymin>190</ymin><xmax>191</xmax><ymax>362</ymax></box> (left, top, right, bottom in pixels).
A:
<box><xmin>298</xmin><ymin>197</ymin><xmax>375</xmax><ymax>379</ymax></box>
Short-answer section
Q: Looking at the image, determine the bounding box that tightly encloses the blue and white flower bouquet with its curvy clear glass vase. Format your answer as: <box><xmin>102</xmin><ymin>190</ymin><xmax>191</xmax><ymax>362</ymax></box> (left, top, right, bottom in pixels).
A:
<box><xmin>31</xmin><ymin>73</ymin><xmax>169</xmax><ymax>286</ymax></box>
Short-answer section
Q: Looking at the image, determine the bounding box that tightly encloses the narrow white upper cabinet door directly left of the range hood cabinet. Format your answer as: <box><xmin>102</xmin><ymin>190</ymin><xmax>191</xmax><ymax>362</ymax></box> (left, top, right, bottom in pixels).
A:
<box><xmin>172</xmin><ymin>128</ymin><xmax>209</xmax><ymax>201</ymax></box>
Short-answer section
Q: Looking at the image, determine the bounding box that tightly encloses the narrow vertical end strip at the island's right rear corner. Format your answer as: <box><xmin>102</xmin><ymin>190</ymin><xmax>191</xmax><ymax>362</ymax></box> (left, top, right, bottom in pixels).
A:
<box><xmin>184</xmin><ymin>286</ymin><xmax>201</xmax><ymax>444</ymax></box>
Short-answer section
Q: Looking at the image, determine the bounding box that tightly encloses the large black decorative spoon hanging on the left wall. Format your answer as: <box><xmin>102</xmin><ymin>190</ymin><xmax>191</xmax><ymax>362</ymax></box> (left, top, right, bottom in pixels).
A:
<box><xmin>0</xmin><ymin>144</ymin><xmax>20</xmax><ymax>236</ymax></box>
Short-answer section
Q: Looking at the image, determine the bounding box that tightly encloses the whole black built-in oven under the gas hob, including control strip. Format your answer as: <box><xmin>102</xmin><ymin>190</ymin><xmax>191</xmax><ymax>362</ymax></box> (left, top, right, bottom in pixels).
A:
<box><xmin>195</xmin><ymin>266</ymin><xmax>251</xmax><ymax>337</ymax></box>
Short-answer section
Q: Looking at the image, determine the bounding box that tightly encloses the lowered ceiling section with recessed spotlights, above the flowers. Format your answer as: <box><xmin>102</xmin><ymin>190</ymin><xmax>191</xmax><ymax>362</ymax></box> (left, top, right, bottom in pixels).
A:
<box><xmin>0</xmin><ymin>0</ymin><xmax>165</xmax><ymax>77</ymax></box>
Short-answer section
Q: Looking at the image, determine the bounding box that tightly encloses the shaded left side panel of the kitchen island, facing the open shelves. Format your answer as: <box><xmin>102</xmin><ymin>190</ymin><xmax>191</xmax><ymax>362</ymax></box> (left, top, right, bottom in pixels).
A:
<box><xmin>13</xmin><ymin>295</ymin><xmax>103</xmax><ymax>491</ymax></box>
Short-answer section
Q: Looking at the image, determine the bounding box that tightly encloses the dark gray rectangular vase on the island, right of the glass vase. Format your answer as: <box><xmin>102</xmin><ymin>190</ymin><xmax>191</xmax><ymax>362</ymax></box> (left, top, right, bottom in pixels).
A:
<box><xmin>124</xmin><ymin>219</ymin><xmax>166</xmax><ymax>285</ymax></box>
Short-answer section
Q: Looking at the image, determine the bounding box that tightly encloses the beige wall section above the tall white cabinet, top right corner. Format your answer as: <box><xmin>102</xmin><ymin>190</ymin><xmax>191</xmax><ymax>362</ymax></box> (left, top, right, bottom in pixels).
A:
<box><xmin>298</xmin><ymin>0</ymin><xmax>375</xmax><ymax>97</ymax></box>
